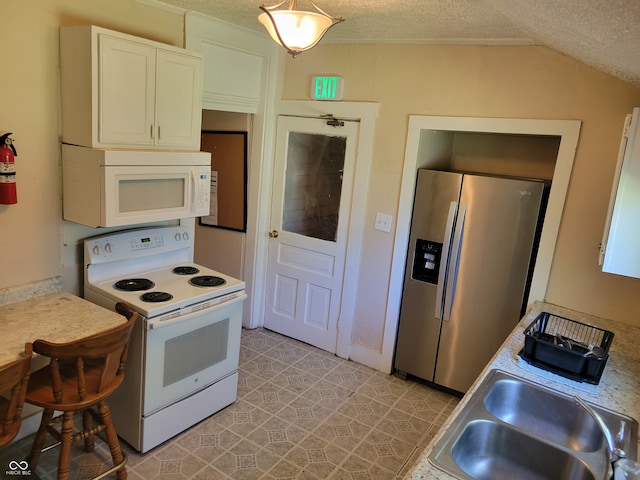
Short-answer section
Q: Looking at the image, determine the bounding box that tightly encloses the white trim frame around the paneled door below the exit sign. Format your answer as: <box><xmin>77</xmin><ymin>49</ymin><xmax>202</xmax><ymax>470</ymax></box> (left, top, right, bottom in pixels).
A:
<box><xmin>253</xmin><ymin>100</ymin><xmax>379</xmax><ymax>358</ymax></box>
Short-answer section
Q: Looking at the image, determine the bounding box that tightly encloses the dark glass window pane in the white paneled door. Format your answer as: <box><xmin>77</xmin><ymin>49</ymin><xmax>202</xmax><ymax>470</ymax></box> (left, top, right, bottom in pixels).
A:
<box><xmin>282</xmin><ymin>132</ymin><xmax>347</xmax><ymax>242</ymax></box>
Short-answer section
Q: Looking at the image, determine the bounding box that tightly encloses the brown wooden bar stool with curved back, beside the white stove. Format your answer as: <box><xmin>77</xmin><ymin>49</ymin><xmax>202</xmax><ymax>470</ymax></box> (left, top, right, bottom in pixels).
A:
<box><xmin>26</xmin><ymin>304</ymin><xmax>138</xmax><ymax>480</ymax></box>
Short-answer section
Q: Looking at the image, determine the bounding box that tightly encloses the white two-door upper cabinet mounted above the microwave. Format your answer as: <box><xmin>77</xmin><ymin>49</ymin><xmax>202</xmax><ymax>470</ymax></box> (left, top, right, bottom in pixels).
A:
<box><xmin>60</xmin><ymin>26</ymin><xmax>203</xmax><ymax>150</ymax></box>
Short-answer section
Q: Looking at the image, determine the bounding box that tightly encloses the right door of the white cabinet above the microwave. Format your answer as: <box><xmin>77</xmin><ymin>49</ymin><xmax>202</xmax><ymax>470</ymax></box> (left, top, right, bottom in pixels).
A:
<box><xmin>154</xmin><ymin>49</ymin><xmax>202</xmax><ymax>149</ymax></box>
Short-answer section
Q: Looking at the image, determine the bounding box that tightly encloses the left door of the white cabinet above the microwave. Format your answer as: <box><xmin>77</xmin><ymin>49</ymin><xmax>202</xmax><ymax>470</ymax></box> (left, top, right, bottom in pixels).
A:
<box><xmin>98</xmin><ymin>35</ymin><xmax>156</xmax><ymax>145</ymax></box>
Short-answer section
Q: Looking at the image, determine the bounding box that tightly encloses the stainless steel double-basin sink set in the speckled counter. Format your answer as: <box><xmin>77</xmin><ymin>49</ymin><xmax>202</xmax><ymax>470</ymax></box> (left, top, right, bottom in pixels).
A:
<box><xmin>429</xmin><ymin>370</ymin><xmax>638</xmax><ymax>480</ymax></box>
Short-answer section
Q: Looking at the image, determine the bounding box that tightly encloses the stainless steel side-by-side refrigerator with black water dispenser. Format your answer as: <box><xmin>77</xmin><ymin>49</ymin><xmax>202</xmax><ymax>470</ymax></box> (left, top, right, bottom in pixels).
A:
<box><xmin>394</xmin><ymin>169</ymin><xmax>545</xmax><ymax>392</ymax></box>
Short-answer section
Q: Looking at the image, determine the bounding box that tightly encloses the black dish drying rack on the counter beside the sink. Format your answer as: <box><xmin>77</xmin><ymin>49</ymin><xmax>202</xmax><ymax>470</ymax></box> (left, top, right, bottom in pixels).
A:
<box><xmin>518</xmin><ymin>312</ymin><xmax>613</xmax><ymax>385</ymax></box>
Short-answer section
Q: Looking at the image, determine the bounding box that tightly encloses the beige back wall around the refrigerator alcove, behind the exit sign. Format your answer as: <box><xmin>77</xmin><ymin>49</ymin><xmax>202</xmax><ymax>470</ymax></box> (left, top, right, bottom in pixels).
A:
<box><xmin>283</xmin><ymin>44</ymin><xmax>640</xmax><ymax>350</ymax></box>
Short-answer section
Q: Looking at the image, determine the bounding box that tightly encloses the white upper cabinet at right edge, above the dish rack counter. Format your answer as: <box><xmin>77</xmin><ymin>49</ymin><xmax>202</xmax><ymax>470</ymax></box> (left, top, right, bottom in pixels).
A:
<box><xmin>599</xmin><ymin>108</ymin><xmax>640</xmax><ymax>278</ymax></box>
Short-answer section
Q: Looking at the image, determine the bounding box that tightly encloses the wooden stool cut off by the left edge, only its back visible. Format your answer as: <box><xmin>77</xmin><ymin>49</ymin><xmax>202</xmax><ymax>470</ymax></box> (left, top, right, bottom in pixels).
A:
<box><xmin>0</xmin><ymin>343</ymin><xmax>32</xmax><ymax>447</ymax></box>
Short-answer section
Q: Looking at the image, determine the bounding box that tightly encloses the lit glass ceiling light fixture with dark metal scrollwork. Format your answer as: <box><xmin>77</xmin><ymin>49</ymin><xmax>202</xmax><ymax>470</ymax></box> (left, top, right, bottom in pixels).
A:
<box><xmin>258</xmin><ymin>0</ymin><xmax>344</xmax><ymax>57</ymax></box>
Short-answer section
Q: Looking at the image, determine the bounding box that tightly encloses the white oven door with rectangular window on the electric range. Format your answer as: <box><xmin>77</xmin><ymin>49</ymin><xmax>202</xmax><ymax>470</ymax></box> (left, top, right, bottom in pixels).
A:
<box><xmin>143</xmin><ymin>300</ymin><xmax>242</xmax><ymax>415</ymax></box>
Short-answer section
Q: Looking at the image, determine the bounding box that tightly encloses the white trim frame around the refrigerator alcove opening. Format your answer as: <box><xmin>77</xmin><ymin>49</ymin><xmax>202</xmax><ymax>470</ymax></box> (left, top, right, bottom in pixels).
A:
<box><xmin>381</xmin><ymin>115</ymin><xmax>582</xmax><ymax>373</ymax></box>
